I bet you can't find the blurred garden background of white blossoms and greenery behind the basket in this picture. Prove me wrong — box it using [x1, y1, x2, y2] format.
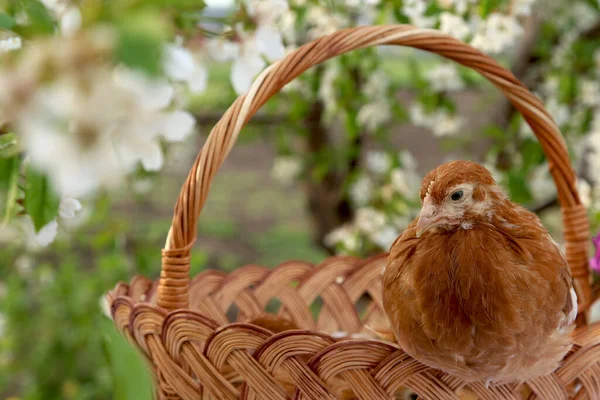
[0, 0, 600, 400]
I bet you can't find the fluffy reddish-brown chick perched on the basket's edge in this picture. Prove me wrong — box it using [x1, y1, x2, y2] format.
[383, 161, 577, 384]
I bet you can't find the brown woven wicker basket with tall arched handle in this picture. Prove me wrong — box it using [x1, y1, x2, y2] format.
[107, 25, 600, 400]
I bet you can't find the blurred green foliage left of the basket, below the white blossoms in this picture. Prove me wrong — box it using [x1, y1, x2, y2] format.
[0, 193, 161, 400]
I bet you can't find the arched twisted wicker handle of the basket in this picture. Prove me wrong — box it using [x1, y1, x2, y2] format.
[157, 25, 592, 313]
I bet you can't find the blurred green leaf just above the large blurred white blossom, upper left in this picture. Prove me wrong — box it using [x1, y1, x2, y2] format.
[115, 11, 170, 75]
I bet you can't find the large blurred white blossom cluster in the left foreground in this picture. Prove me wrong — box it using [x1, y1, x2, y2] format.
[5, 43, 195, 197]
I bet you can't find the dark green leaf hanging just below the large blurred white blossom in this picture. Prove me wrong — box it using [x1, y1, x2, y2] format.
[25, 167, 60, 231]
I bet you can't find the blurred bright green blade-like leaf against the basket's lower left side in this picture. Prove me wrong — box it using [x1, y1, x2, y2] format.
[101, 319, 152, 400]
